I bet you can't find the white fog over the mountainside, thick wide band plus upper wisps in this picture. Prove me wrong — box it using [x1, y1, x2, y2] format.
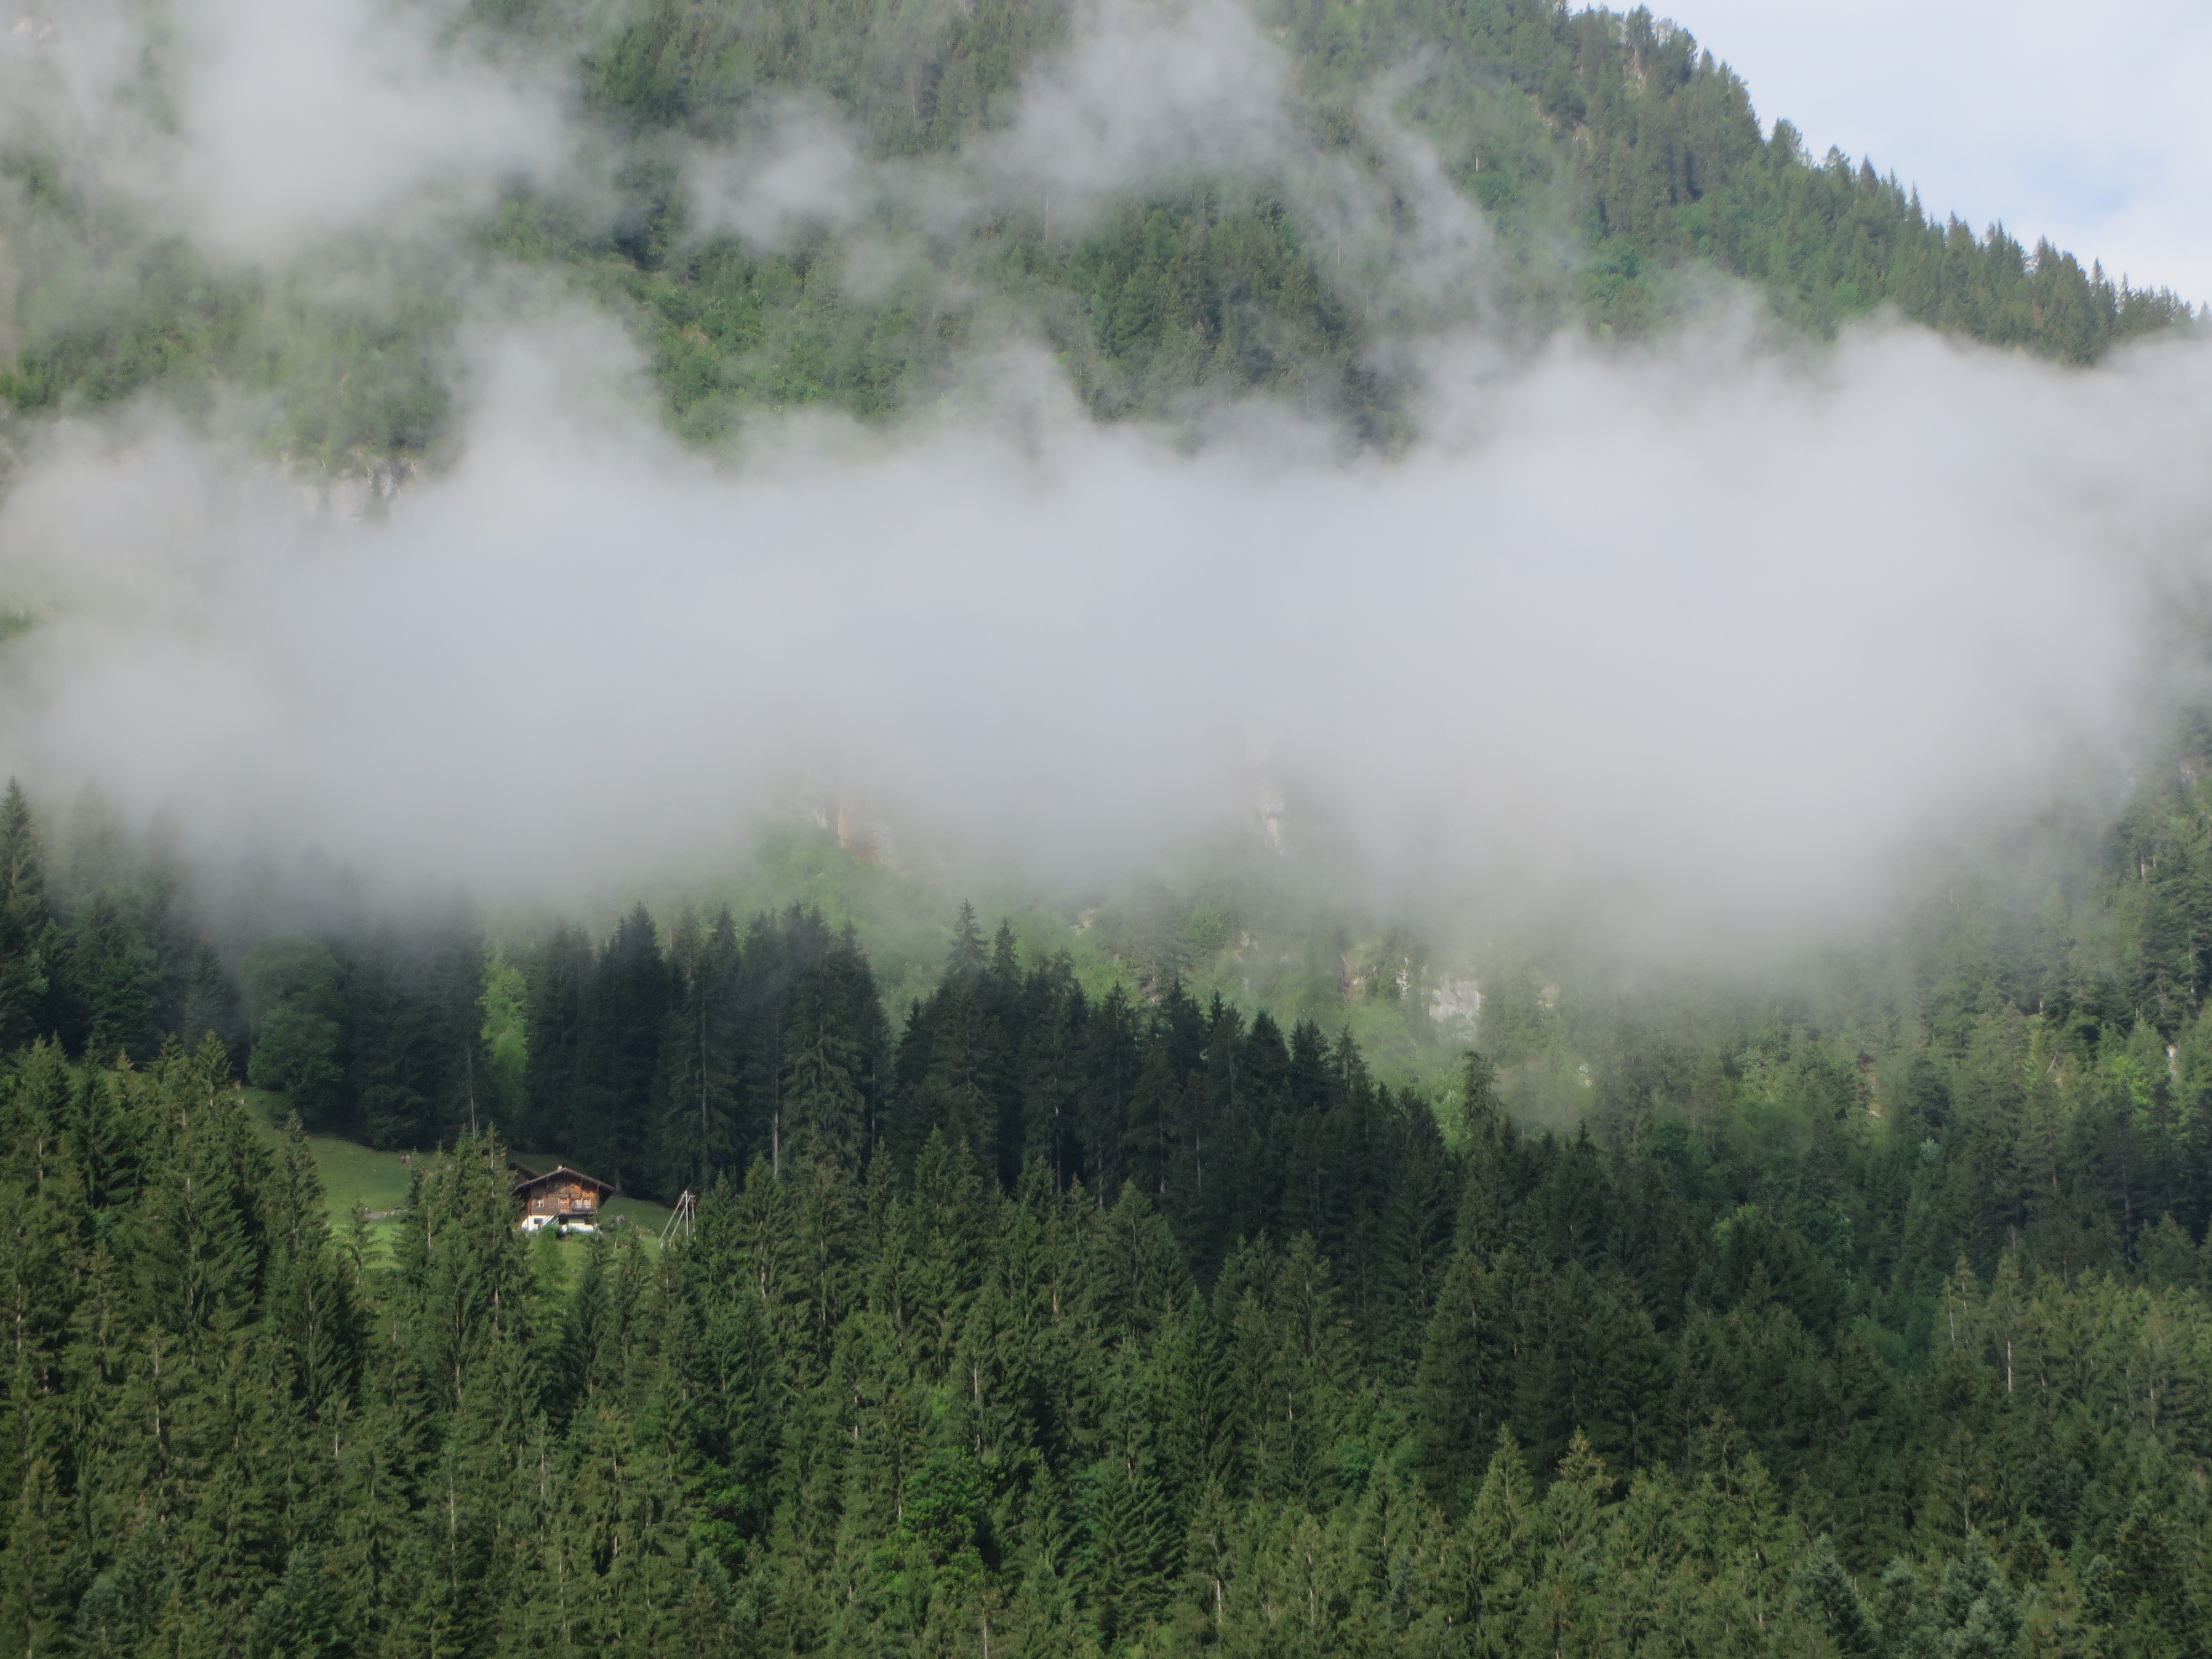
[0, 0, 2212, 945]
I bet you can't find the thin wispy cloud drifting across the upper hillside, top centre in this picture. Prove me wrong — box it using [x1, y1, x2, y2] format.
[664, 0, 1498, 354]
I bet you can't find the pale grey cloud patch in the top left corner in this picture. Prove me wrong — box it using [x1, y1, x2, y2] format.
[0, 0, 568, 263]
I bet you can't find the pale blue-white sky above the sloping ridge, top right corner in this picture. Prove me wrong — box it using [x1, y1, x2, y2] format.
[1661, 0, 2212, 303]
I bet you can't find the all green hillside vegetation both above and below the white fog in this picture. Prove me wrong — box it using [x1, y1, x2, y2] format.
[0, 0, 2212, 1659]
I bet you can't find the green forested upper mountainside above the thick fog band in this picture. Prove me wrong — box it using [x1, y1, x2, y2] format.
[0, 0, 2190, 478]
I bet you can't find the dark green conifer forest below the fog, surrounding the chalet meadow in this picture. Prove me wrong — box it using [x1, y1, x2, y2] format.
[0, 748, 2212, 1659]
